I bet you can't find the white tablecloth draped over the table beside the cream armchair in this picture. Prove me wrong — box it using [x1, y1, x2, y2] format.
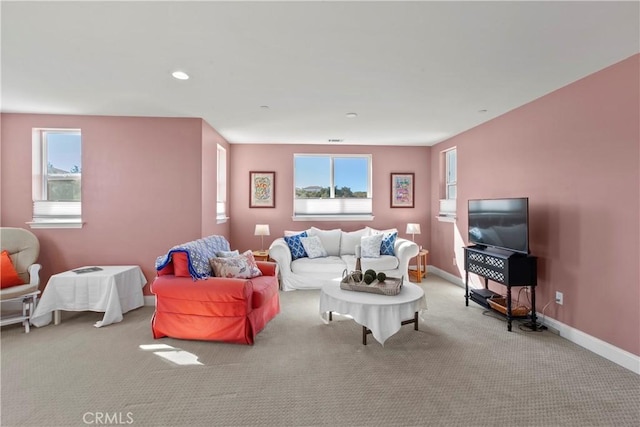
[31, 265, 147, 328]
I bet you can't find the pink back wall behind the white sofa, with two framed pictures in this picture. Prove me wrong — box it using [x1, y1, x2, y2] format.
[230, 144, 431, 250]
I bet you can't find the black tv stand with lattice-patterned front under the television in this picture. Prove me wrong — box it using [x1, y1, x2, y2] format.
[464, 246, 538, 331]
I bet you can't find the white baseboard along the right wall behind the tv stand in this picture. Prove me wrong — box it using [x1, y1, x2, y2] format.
[427, 265, 640, 375]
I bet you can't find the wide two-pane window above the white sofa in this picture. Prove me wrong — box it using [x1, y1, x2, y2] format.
[293, 154, 373, 220]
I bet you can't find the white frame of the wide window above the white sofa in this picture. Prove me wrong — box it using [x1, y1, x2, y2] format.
[292, 153, 374, 221]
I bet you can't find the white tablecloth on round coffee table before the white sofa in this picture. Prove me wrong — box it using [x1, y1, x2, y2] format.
[320, 280, 427, 345]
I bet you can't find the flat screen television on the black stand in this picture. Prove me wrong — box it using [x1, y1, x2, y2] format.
[469, 197, 529, 254]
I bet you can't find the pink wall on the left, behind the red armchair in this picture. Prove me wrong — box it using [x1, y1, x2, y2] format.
[0, 114, 228, 293]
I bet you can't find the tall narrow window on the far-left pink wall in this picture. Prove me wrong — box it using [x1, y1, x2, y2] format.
[29, 129, 82, 228]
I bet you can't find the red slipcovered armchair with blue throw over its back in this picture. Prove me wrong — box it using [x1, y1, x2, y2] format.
[151, 261, 280, 344]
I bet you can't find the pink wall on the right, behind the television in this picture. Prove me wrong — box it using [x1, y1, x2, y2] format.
[430, 55, 640, 355]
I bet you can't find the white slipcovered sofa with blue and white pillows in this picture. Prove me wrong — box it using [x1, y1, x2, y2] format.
[269, 227, 419, 291]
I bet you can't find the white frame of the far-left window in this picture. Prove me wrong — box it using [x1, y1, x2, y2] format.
[27, 128, 84, 228]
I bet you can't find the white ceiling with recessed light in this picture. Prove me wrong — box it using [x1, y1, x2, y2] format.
[0, 1, 640, 145]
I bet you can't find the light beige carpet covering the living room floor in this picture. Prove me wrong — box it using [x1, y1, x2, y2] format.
[0, 275, 640, 426]
